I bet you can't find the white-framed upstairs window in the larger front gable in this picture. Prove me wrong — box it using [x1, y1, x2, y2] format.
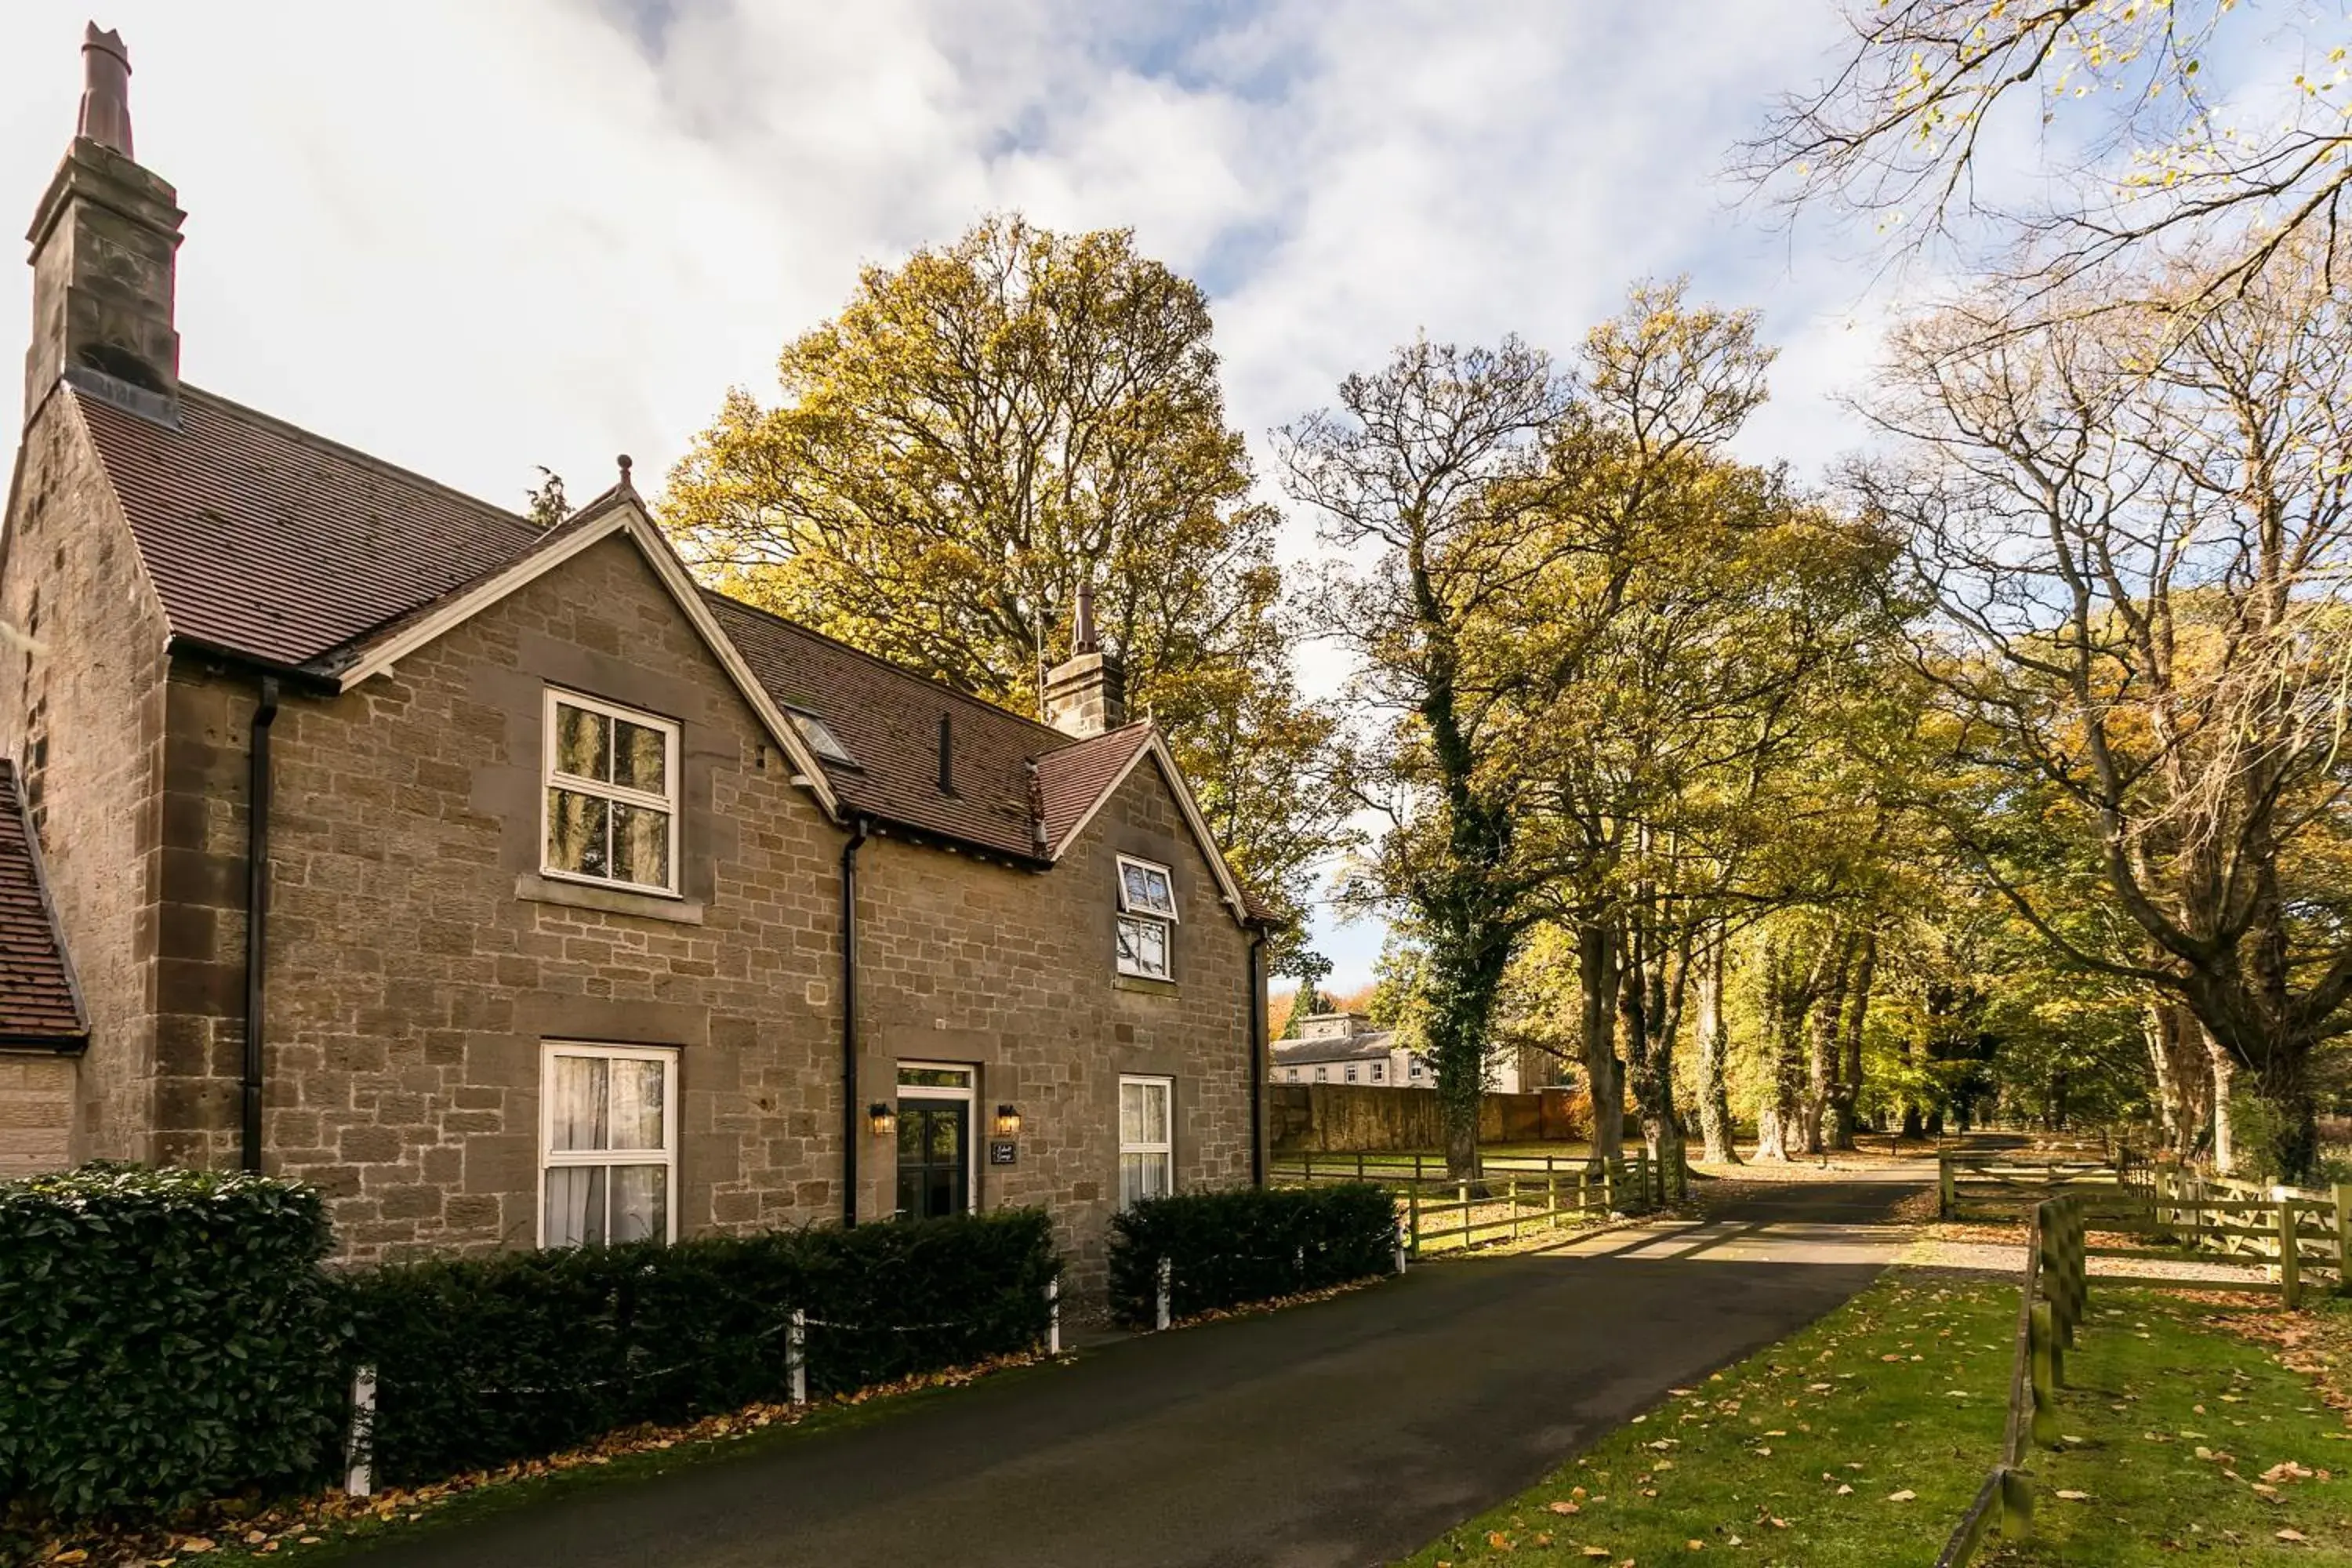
[539, 687, 677, 893]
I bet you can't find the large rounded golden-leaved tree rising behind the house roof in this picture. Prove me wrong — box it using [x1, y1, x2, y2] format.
[663, 216, 1345, 959]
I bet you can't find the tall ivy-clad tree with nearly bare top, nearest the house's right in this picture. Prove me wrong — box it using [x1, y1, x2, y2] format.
[1279, 339, 1566, 1175]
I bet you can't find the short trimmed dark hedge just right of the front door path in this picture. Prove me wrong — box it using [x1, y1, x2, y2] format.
[1110, 1182, 1397, 1326]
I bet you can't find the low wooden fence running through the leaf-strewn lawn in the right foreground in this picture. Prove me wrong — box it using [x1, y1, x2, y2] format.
[1936, 1196, 2091, 1568]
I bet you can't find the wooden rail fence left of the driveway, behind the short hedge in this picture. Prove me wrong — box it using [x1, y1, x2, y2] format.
[1268, 1145, 1665, 1258]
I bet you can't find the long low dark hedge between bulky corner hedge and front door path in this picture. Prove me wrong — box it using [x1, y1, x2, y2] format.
[348, 1210, 1061, 1483]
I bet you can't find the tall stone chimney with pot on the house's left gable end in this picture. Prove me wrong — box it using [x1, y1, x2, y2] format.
[24, 24, 188, 421]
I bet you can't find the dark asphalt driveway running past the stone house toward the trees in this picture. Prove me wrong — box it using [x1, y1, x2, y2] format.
[336, 1180, 1905, 1568]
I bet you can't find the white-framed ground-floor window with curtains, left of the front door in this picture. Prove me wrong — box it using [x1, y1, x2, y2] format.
[539, 1039, 677, 1246]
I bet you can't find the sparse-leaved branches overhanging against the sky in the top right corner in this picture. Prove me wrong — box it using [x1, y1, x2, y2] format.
[1740, 0, 2352, 303]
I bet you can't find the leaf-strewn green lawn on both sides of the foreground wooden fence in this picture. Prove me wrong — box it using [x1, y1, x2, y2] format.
[1409, 1269, 2352, 1568]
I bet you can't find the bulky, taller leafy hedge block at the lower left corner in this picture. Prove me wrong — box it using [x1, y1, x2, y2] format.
[0, 1166, 341, 1516]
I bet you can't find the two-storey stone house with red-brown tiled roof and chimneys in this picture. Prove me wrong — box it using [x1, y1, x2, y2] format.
[0, 31, 1265, 1288]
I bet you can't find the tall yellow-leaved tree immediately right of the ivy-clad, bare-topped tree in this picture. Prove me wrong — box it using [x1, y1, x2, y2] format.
[1491, 282, 1891, 1180]
